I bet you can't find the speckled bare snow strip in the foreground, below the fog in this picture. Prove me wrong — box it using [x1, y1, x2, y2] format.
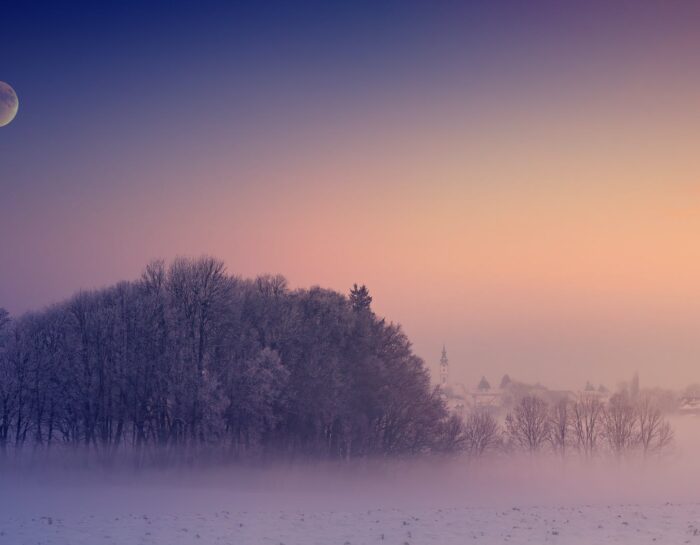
[0, 504, 700, 545]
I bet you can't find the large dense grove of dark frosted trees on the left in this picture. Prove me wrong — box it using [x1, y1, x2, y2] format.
[0, 257, 461, 458]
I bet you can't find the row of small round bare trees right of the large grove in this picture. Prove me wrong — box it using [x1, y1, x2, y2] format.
[453, 392, 674, 459]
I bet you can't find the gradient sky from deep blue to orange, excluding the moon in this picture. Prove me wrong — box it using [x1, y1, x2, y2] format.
[0, 1, 700, 388]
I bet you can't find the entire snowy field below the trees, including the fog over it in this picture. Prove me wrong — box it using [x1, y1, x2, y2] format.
[0, 416, 700, 545]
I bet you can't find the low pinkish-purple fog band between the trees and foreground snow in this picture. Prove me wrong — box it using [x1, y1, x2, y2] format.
[0, 417, 700, 516]
